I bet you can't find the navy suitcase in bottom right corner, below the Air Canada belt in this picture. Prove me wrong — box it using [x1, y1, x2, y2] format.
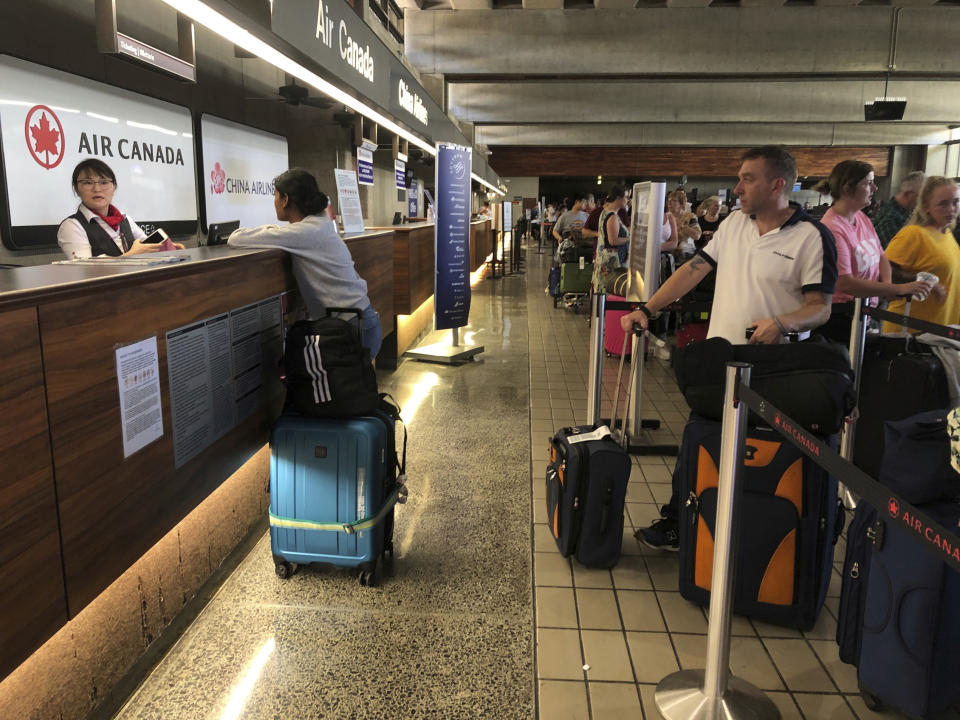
[857, 502, 960, 718]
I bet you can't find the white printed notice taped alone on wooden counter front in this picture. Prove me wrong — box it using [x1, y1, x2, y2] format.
[114, 337, 163, 458]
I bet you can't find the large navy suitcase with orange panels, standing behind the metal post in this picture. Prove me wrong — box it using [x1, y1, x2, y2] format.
[674, 415, 840, 629]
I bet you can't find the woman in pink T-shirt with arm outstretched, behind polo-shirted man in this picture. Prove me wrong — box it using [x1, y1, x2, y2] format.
[814, 160, 930, 345]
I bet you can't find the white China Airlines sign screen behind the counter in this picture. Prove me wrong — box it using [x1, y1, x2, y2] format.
[200, 115, 290, 232]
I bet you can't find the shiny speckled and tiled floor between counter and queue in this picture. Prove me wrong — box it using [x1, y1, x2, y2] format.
[117, 249, 891, 720]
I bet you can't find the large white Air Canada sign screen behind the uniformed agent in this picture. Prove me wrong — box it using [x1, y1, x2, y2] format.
[0, 55, 197, 250]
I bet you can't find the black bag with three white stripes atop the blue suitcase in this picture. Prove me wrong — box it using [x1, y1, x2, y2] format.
[283, 308, 380, 418]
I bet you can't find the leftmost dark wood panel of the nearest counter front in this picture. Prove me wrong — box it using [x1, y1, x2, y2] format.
[0, 308, 67, 677]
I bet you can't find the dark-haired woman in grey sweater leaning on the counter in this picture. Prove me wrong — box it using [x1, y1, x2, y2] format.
[227, 168, 383, 360]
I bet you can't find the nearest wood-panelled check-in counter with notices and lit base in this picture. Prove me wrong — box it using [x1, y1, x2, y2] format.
[0, 231, 394, 677]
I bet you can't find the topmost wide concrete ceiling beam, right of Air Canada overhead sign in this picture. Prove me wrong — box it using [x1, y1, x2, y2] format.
[404, 7, 960, 76]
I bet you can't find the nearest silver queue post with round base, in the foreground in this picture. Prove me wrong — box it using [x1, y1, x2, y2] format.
[654, 363, 780, 720]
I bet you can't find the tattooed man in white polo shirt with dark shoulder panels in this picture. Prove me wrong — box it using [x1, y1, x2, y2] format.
[621, 145, 837, 550]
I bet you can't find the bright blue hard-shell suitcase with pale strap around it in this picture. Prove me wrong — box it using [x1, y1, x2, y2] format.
[270, 411, 406, 585]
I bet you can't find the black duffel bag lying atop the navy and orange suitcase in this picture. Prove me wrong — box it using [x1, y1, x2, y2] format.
[674, 336, 856, 435]
